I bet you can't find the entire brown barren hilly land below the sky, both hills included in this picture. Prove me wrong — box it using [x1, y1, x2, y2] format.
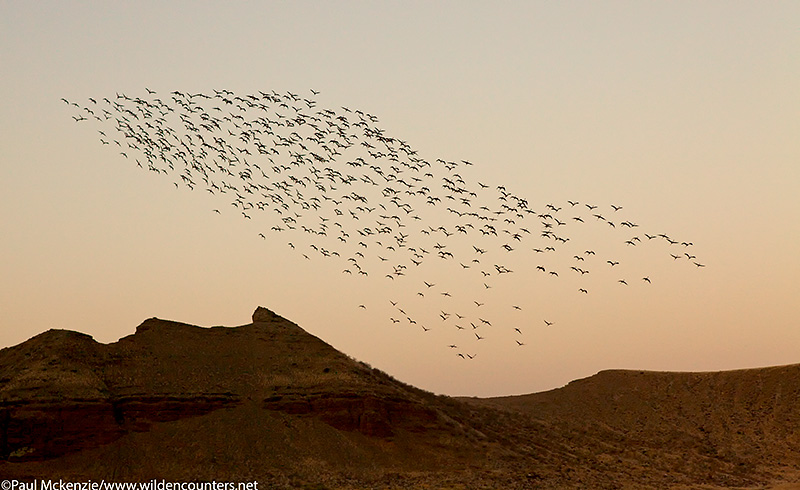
[0, 307, 800, 489]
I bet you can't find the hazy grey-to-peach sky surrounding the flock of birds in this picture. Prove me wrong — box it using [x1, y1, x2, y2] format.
[0, 0, 800, 396]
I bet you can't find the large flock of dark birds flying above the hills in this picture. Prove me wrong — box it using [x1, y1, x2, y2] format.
[62, 89, 704, 359]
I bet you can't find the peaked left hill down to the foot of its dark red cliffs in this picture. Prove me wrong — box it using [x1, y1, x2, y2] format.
[0, 307, 445, 461]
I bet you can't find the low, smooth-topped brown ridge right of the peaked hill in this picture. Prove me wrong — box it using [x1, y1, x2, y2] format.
[472, 364, 800, 484]
